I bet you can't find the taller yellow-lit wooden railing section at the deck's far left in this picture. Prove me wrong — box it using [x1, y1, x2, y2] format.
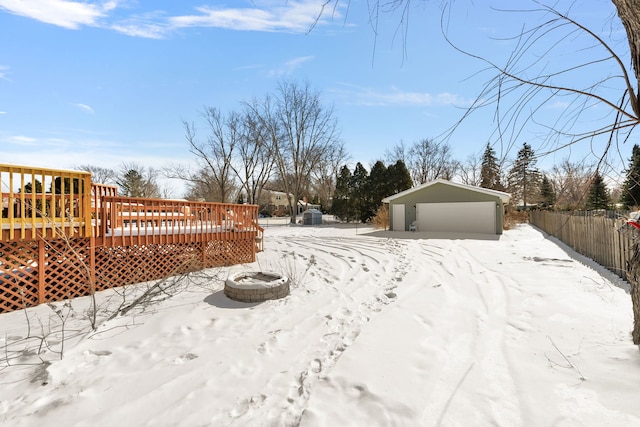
[0, 164, 92, 240]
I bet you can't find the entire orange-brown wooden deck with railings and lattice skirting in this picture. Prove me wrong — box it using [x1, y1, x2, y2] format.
[0, 164, 264, 313]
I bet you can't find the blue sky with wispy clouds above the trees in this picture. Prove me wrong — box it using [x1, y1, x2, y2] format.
[0, 0, 631, 194]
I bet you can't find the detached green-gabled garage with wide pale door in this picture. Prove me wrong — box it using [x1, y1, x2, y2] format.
[382, 179, 511, 234]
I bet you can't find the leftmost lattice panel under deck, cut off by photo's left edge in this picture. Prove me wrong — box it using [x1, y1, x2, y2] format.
[0, 241, 38, 313]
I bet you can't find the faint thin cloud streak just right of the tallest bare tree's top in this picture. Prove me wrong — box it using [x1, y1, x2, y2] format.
[333, 86, 472, 107]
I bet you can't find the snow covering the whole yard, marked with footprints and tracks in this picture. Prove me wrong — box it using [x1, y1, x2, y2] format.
[0, 225, 640, 426]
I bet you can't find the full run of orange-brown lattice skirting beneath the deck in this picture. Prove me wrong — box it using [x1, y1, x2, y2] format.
[0, 234, 256, 313]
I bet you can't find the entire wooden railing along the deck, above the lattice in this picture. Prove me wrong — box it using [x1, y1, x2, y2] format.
[0, 164, 264, 251]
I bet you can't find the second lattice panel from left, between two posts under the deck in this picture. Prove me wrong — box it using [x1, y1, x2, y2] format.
[42, 239, 91, 302]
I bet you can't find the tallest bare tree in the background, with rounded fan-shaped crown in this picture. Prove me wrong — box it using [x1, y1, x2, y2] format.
[259, 81, 341, 223]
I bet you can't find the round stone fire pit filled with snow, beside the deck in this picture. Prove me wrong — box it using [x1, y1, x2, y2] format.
[224, 271, 289, 302]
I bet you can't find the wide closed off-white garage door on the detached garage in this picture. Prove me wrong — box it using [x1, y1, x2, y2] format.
[416, 202, 496, 234]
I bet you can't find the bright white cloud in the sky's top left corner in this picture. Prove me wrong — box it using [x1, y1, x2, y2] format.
[0, 0, 106, 29]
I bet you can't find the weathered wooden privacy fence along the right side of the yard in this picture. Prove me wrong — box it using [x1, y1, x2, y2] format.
[529, 211, 635, 280]
